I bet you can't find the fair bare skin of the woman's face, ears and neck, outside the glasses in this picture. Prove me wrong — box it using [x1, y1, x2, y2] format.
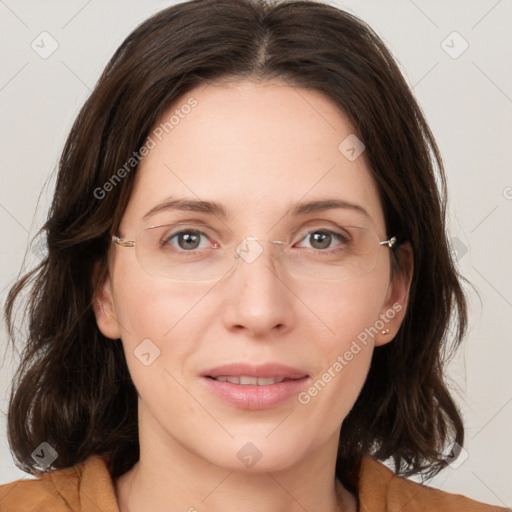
[95, 81, 412, 512]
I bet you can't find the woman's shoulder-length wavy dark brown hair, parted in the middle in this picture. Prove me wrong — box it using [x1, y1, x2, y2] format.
[5, 0, 467, 487]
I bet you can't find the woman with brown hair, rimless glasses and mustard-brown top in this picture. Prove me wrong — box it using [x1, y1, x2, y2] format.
[0, 0, 504, 512]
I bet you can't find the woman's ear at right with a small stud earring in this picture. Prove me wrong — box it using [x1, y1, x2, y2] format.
[374, 242, 414, 347]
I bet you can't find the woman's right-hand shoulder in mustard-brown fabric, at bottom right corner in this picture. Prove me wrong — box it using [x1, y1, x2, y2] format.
[358, 457, 510, 512]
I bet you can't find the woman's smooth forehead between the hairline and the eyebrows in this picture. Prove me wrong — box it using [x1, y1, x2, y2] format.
[123, 81, 383, 230]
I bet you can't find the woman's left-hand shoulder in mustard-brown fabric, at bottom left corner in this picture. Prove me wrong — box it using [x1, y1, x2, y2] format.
[0, 455, 118, 512]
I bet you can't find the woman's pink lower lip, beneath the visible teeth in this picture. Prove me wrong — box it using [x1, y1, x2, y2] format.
[204, 377, 308, 411]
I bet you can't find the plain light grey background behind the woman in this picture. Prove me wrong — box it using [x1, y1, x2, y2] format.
[0, 0, 512, 507]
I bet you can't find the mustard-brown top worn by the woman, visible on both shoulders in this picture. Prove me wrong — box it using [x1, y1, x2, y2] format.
[0, 456, 511, 512]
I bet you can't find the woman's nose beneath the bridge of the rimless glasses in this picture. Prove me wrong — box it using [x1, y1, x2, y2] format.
[222, 237, 296, 339]
